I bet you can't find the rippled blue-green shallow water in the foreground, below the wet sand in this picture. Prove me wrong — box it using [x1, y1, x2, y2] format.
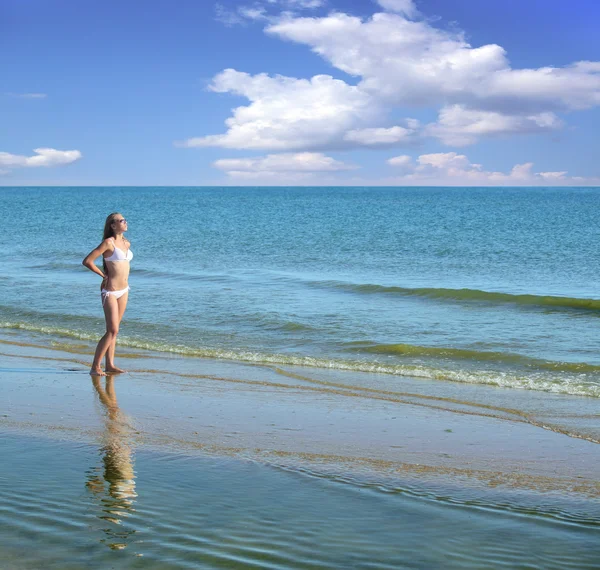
[0, 433, 600, 570]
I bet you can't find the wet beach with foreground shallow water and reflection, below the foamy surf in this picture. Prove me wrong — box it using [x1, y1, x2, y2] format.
[0, 335, 600, 568]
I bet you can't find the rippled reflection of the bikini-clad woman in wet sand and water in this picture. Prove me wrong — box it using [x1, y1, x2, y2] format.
[86, 376, 137, 549]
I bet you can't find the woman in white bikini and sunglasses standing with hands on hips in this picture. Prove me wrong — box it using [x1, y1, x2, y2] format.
[82, 212, 133, 376]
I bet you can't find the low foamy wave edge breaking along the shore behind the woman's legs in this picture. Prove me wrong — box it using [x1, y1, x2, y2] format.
[0, 315, 600, 398]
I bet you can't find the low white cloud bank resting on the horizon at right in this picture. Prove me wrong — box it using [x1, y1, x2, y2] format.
[387, 152, 600, 186]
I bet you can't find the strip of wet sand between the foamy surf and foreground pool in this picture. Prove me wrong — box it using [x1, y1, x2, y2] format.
[0, 332, 600, 499]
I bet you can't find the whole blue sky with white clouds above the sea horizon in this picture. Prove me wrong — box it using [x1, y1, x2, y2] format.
[0, 0, 600, 186]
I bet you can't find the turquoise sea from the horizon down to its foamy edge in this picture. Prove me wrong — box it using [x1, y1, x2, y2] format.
[0, 188, 600, 398]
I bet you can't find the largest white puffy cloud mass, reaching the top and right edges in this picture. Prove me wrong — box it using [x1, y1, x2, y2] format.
[192, 0, 600, 151]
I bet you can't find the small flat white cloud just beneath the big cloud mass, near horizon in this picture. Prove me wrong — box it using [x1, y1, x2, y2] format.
[213, 152, 357, 175]
